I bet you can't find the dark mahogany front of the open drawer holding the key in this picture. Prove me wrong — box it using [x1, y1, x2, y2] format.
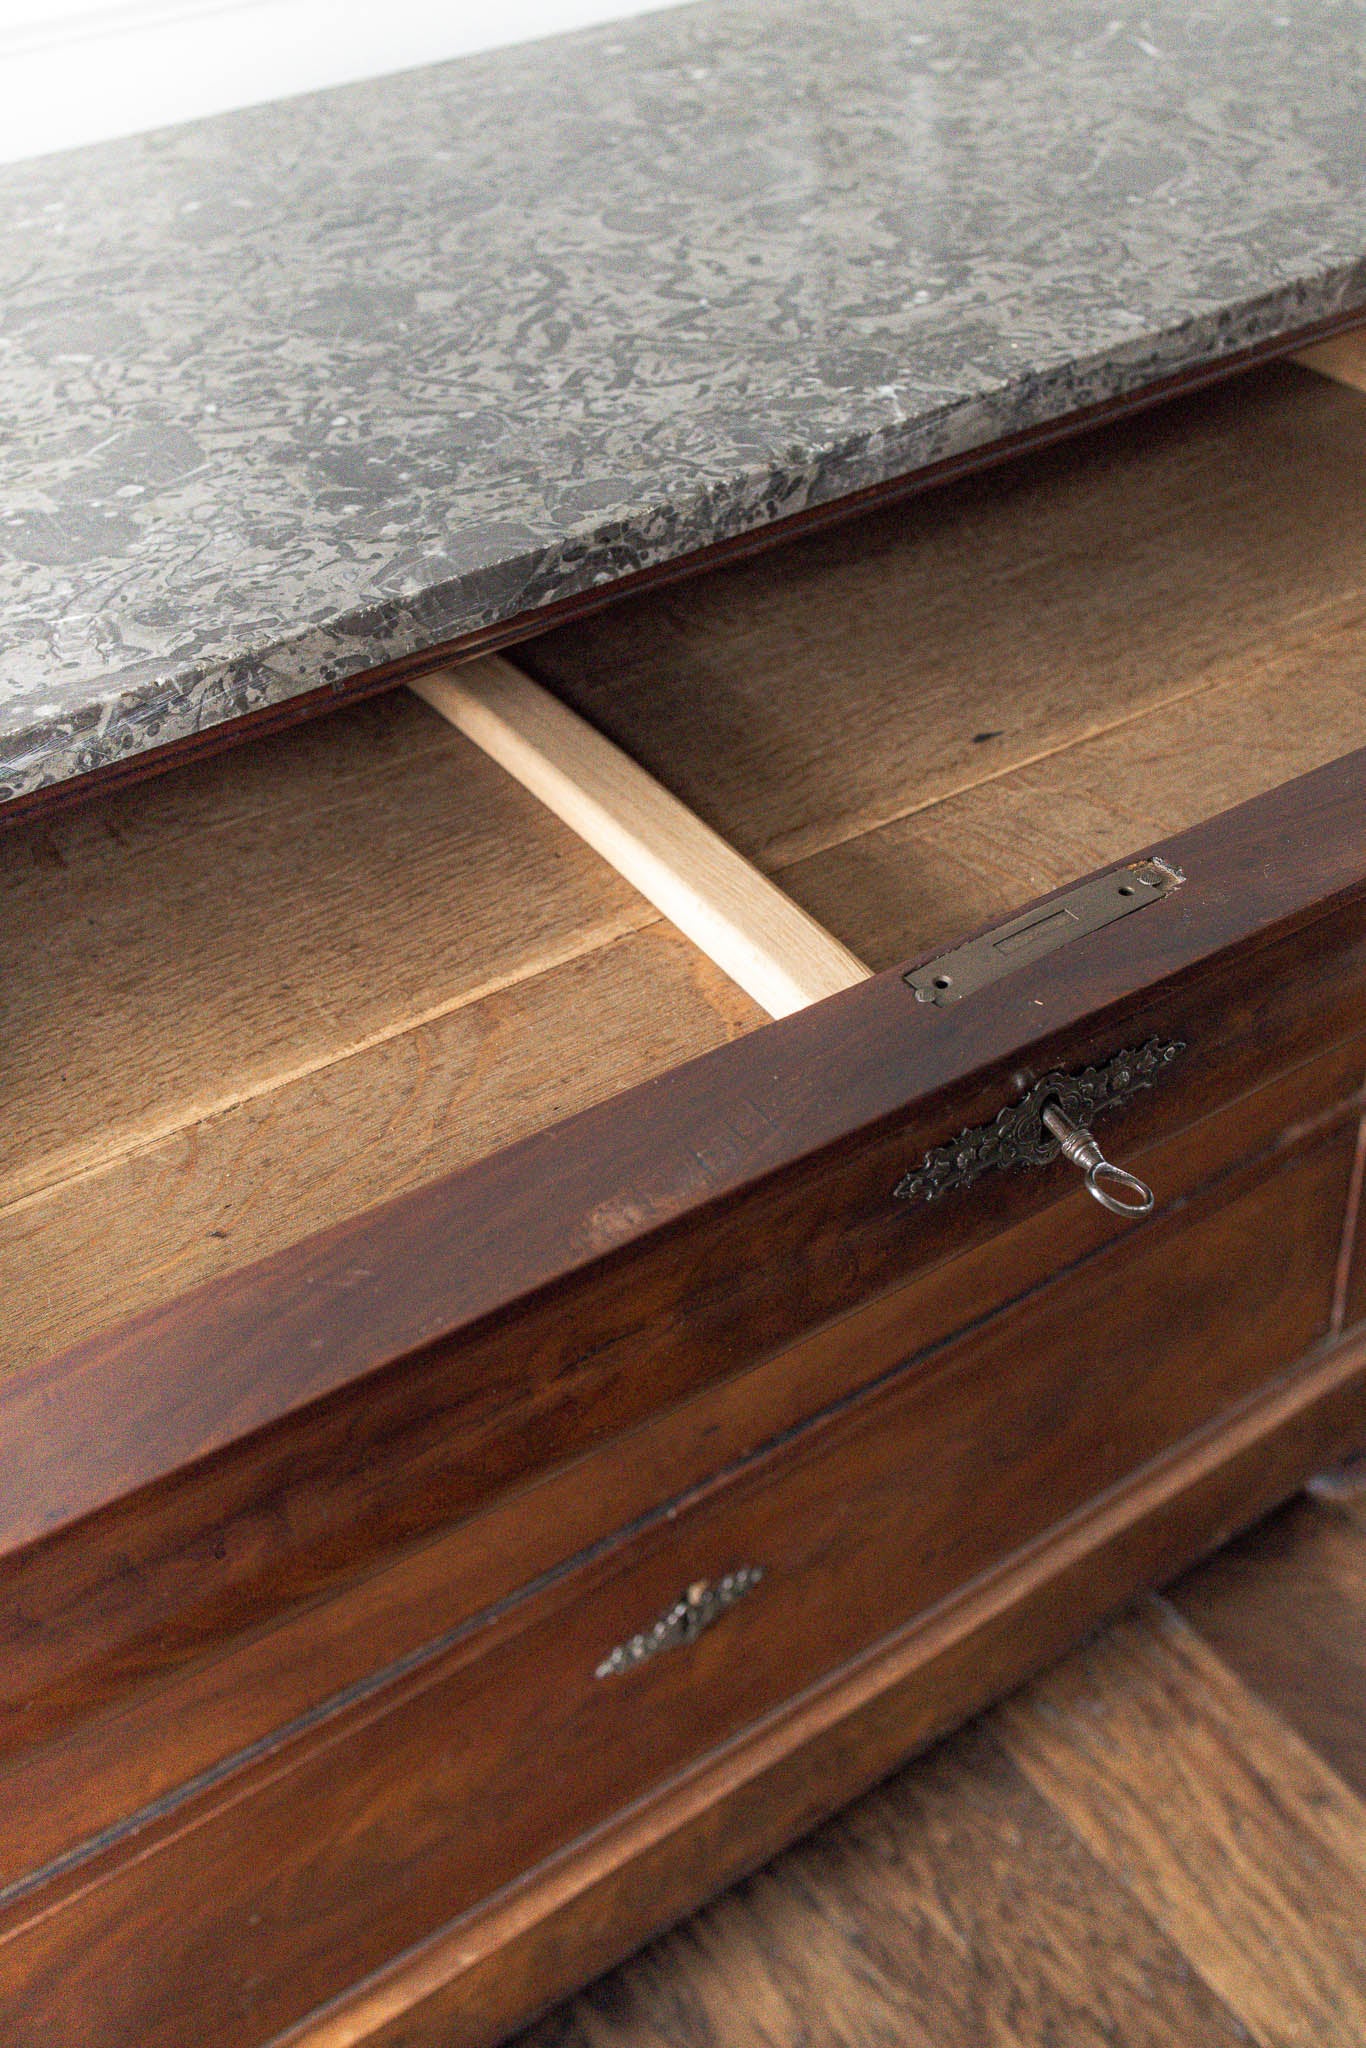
[0, 864, 1366, 1751]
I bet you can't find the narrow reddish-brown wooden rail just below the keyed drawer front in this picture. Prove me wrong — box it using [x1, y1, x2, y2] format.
[0, 1036, 1366, 1886]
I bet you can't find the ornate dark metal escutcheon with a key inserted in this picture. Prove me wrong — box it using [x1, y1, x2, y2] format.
[893, 1038, 1186, 1217]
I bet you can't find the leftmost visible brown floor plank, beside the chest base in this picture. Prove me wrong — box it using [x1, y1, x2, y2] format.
[520, 1726, 1245, 2048]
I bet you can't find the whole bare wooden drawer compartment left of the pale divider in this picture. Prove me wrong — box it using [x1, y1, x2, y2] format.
[0, 698, 762, 1372]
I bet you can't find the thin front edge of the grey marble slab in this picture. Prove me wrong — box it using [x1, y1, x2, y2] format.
[0, 256, 1366, 811]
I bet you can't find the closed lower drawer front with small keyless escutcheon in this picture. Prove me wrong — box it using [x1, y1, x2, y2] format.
[0, 1122, 1354, 2048]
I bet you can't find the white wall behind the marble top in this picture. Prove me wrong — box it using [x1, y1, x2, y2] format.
[0, 0, 676, 162]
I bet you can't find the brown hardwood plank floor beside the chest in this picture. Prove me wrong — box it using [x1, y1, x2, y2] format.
[516, 1489, 1366, 2048]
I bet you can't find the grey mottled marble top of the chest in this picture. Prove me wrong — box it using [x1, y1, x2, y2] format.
[0, 0, 1366, 797]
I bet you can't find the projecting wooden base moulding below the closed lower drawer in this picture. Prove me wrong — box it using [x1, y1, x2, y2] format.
[281, 1348, 1366, 2048]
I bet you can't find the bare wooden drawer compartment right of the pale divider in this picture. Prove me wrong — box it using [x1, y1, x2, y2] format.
[518, 365, 1366, 969]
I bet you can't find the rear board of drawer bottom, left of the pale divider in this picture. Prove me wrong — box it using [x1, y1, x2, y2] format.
[0, 700, 651, 1202]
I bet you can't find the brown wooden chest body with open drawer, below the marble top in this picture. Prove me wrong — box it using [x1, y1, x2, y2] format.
[0, 352, 1366, 2048]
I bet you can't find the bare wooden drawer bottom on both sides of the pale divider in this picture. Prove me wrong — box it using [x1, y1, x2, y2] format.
[0, 367, 1366, 1364]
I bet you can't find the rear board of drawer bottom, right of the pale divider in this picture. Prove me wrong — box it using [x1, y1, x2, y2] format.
[518, 369, 1366, 872]
